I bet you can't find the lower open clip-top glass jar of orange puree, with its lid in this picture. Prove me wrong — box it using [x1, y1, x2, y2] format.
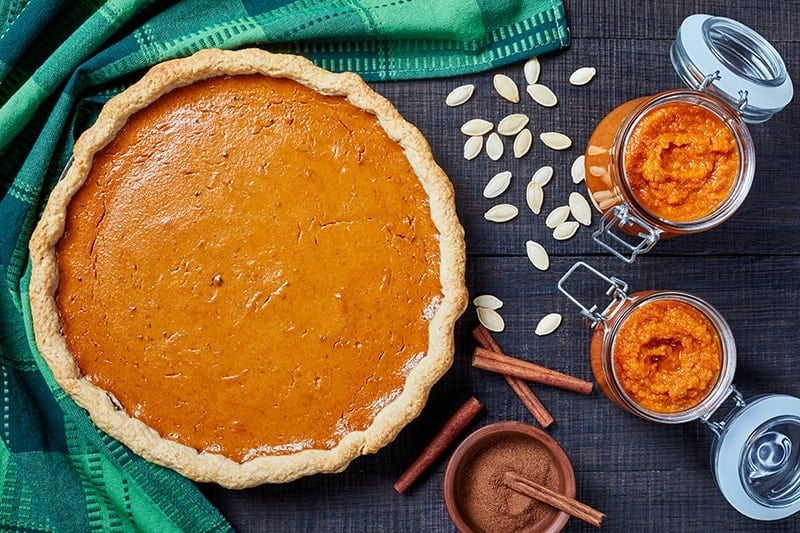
[558, 262, 800, 520]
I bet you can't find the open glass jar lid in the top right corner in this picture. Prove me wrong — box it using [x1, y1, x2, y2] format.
[670, 14, 794, 123]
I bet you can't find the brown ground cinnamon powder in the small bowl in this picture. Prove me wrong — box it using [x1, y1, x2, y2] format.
[456, 434, 563, 533]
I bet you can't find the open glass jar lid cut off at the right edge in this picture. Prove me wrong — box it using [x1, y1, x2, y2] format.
[711, 394, 800, 520]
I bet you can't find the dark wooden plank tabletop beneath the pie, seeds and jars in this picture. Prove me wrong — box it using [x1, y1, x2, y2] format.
[202, 0, 800, 531]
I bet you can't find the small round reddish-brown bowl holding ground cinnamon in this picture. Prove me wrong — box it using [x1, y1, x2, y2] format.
[444, 421, 575, 533]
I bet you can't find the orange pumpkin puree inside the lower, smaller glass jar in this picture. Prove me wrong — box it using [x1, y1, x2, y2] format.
[612, 299, 722, 413]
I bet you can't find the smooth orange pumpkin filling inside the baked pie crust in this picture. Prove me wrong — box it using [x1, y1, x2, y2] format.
[56, 75, 442, 462]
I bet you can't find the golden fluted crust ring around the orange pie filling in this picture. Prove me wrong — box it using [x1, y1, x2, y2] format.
[30, 49, 467, 488]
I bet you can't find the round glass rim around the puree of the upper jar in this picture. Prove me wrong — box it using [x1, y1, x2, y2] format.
[612, 89, 755, 234]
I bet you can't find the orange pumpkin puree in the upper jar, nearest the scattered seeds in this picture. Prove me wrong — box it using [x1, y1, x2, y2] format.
[624, 102, 740, 222]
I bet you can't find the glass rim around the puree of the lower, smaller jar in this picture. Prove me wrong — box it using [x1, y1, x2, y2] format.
[606, 290, 736, 424]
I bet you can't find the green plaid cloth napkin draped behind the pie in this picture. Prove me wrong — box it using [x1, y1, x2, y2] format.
[0, 0, 569, 531]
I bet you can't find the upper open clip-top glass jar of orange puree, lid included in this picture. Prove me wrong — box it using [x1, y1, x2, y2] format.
[585, 15, 793, 263]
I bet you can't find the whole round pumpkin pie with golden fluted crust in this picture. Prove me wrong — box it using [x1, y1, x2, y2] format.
[30, 49, 466, 488]
